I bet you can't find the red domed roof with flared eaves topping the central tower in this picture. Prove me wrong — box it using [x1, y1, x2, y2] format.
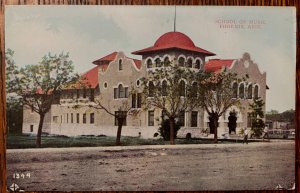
[132, 32, 215, 56]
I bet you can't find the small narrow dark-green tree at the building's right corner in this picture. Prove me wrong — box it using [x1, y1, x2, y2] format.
[250, 98, 265, 137]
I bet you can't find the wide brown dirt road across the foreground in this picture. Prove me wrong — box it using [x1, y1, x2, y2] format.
[7, 141, 295, 191]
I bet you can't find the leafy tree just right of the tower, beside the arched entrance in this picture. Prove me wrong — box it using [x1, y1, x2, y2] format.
[197, 71, 241, 143]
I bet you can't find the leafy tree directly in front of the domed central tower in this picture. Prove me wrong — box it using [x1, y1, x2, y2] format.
[142, 62, 198, 144]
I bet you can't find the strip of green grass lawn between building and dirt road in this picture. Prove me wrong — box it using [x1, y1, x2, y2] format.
[7, 135, 232, 149]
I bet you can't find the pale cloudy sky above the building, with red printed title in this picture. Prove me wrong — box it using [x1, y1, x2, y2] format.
[5, 5, 296, 112]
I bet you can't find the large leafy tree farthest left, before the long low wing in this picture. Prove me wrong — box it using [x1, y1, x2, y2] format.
[9, 53, 78, 147]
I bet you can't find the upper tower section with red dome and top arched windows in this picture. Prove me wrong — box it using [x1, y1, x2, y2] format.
[132, 32, 215, 70]
